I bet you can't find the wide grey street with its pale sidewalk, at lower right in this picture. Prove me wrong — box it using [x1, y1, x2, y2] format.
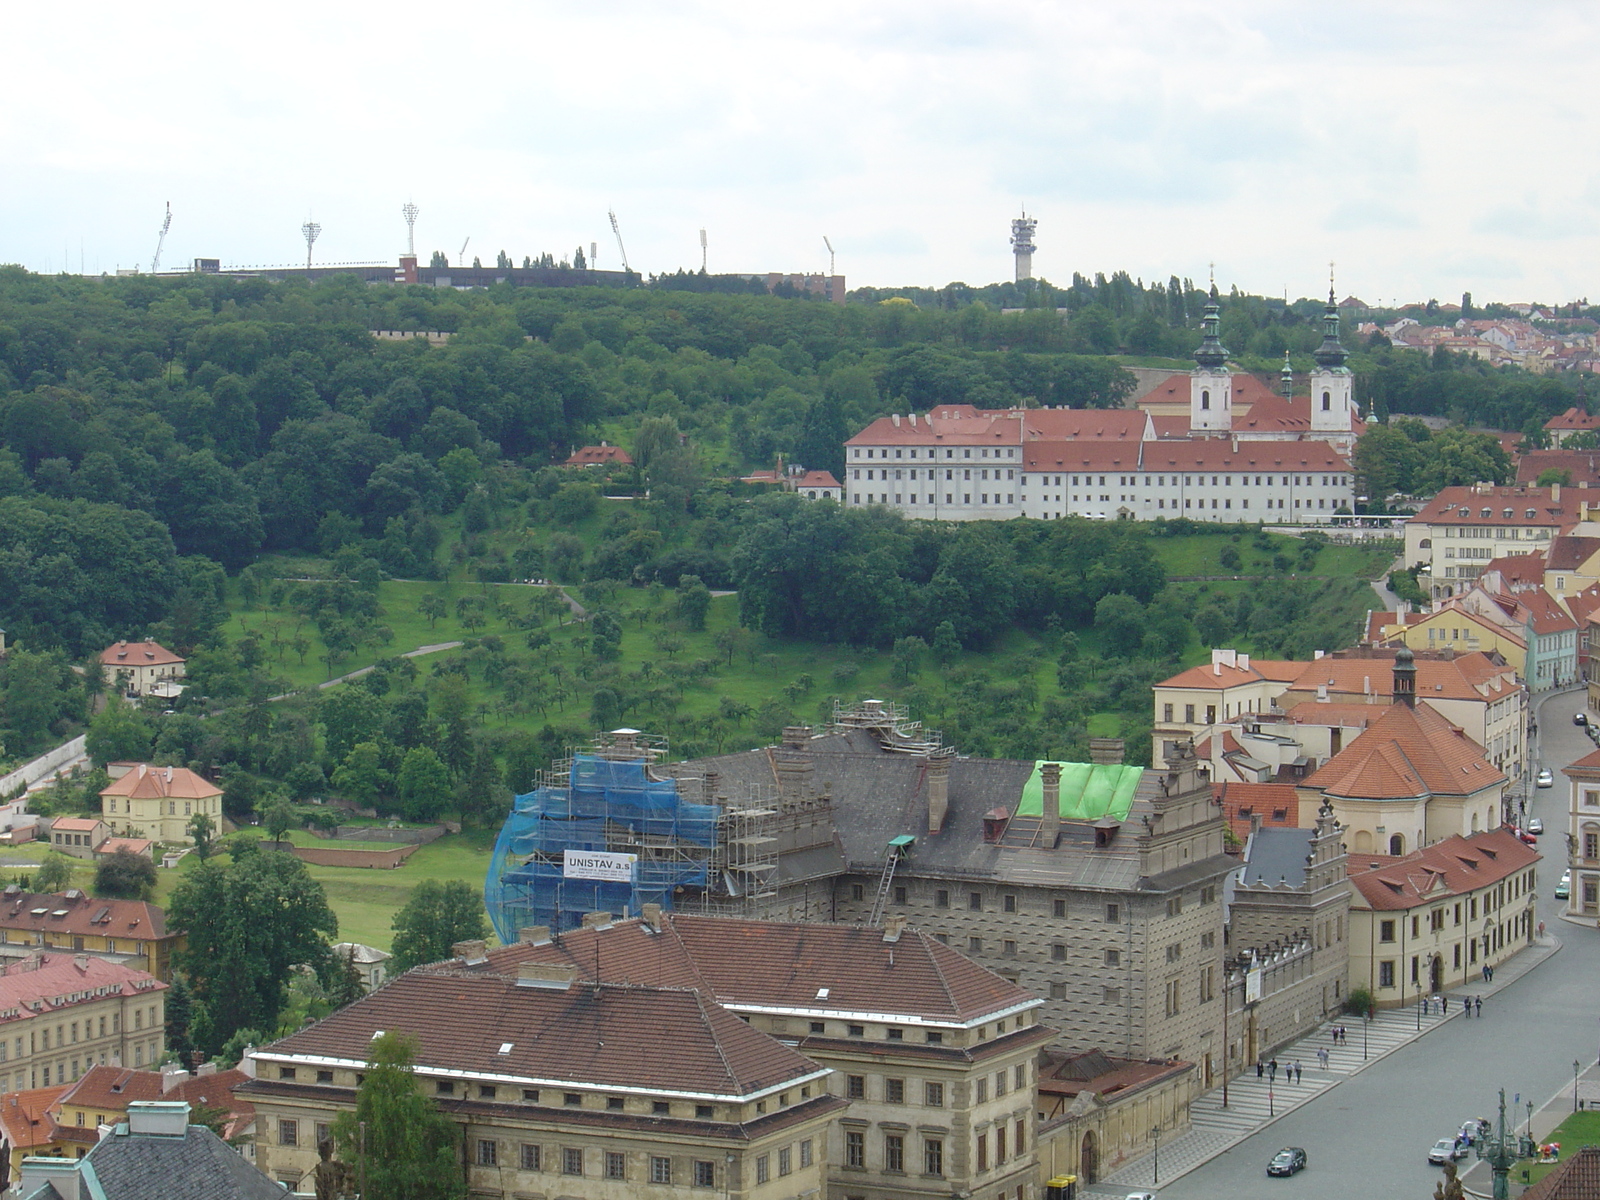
[1094, 693, 1600, 1200]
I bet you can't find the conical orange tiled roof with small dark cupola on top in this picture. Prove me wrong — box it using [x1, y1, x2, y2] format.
[1304, 704, 1506, 800]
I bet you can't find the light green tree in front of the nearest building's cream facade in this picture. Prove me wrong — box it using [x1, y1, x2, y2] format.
[333, 1032, 467, 1200]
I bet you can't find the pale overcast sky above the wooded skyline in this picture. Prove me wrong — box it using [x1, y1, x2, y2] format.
[0, 0, 1600, 310]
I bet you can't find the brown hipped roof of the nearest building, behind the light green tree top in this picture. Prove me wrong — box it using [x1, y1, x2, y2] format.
[261, 972, 819, 1099]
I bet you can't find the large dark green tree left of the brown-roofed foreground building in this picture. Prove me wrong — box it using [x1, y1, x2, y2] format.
[166, 846, 339, 1054]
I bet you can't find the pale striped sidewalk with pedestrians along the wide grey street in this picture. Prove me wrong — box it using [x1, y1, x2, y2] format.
[1082, 931, 1562, 1200]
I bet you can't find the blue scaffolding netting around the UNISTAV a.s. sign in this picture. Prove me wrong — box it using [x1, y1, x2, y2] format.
[483, 755, 720, 944]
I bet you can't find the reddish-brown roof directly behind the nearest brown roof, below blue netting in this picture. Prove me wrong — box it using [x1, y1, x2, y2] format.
[435, 914, 1037, 1024]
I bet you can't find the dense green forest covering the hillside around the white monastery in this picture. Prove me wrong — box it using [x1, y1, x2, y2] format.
[0, 269, 1573, 790]
